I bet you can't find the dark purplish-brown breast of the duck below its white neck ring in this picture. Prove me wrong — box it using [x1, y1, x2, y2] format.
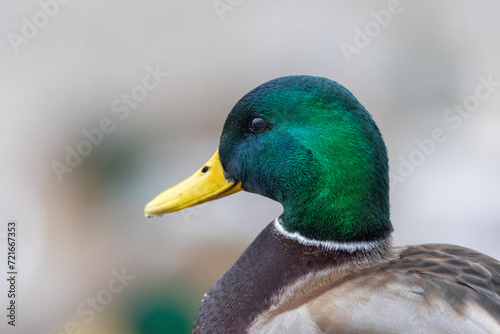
[193, 223, 392, 333]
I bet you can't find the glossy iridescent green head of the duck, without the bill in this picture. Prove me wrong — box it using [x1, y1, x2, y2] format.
[219, 76, 392, 242]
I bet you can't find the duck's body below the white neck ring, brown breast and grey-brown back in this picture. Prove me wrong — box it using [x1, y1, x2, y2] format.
[193, 224, 500, 333]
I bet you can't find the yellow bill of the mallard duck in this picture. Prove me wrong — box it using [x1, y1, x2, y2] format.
[144, 150, 242, 217]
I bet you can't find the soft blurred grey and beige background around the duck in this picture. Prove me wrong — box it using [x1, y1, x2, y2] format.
[0, 0, 500, 334]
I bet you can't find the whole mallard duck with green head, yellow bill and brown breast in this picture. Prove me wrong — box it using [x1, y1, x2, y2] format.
[145, 76, 500, 333]
